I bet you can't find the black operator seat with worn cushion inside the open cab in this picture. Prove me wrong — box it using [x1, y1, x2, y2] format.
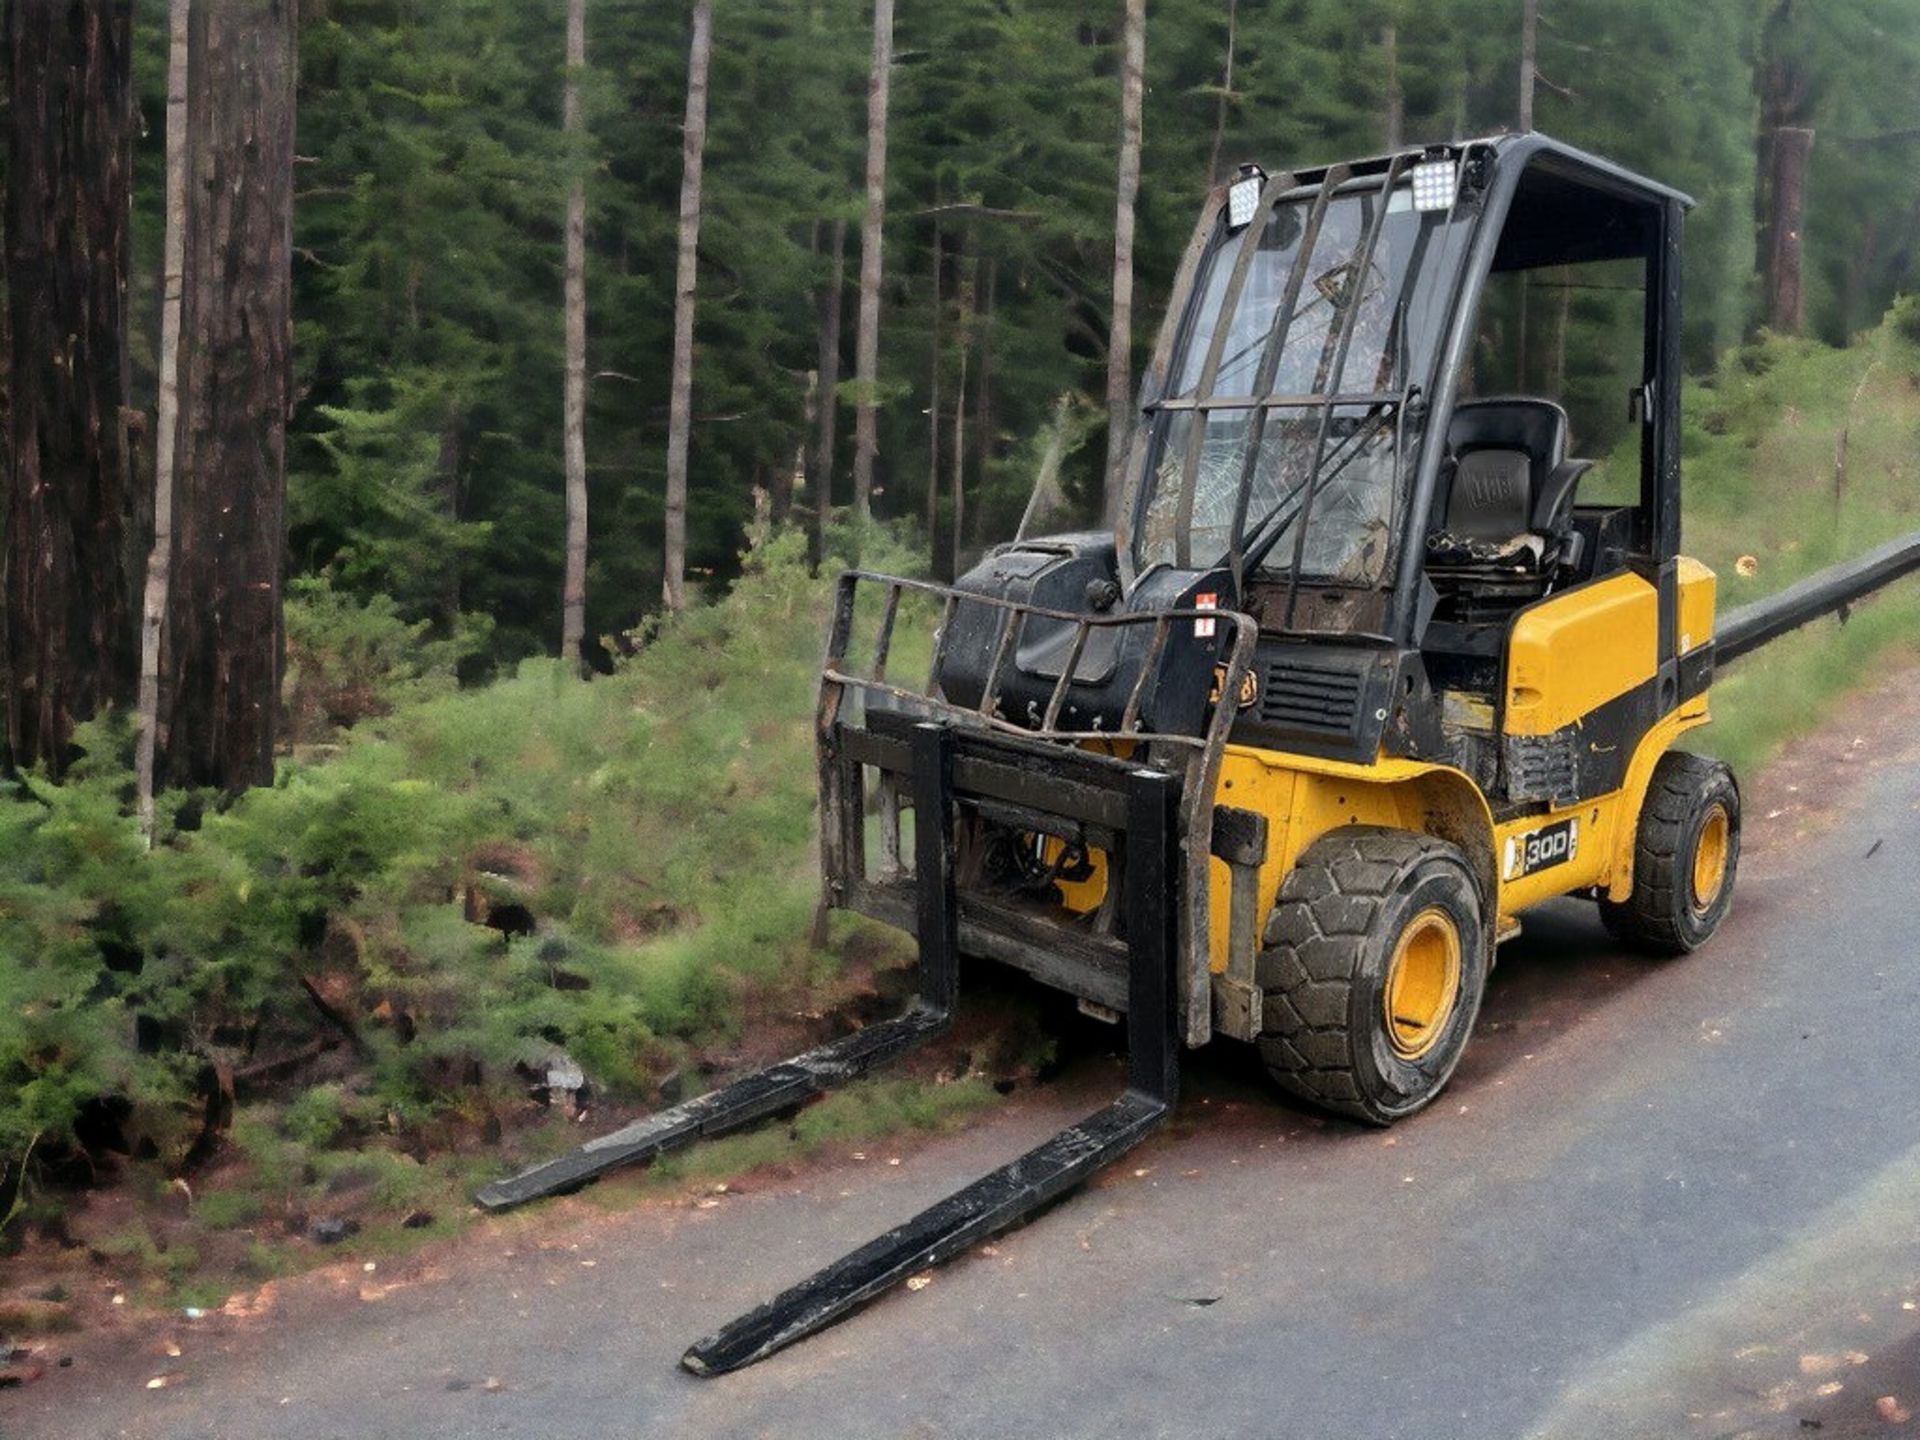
[1427, 396, 1594, 576]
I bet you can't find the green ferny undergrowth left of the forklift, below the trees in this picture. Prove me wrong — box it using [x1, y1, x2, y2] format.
[0, 534, 929, 1281]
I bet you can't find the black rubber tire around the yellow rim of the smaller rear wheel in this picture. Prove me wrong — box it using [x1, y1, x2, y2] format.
[1599, 751, 1740, 956]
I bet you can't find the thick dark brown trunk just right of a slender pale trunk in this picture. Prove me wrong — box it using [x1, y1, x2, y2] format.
[156, 0, 298, 791]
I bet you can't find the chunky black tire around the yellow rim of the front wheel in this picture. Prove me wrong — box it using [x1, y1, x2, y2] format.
[1258, 826, 1488, 1125]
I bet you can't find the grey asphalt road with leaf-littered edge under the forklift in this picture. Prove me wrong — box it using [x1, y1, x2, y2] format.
[0, 682, 1920, 1440]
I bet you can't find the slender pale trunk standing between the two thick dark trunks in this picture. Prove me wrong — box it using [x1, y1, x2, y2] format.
[134, 0, 192, 843]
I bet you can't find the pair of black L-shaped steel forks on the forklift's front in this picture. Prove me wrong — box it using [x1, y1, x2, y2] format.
[478, 722, 1179, 1375]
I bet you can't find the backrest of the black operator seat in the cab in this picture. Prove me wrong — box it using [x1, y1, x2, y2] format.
[1442, 396, 1586, 540]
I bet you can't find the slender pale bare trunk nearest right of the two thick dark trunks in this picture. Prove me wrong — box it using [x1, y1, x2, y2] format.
[561, 0, 588, 676]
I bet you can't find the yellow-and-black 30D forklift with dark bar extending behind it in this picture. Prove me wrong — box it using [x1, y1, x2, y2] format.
[480, 134, 1920, 1375]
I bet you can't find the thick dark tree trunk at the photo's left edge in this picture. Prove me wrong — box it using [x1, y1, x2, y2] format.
[6, 0, 144, 772]
